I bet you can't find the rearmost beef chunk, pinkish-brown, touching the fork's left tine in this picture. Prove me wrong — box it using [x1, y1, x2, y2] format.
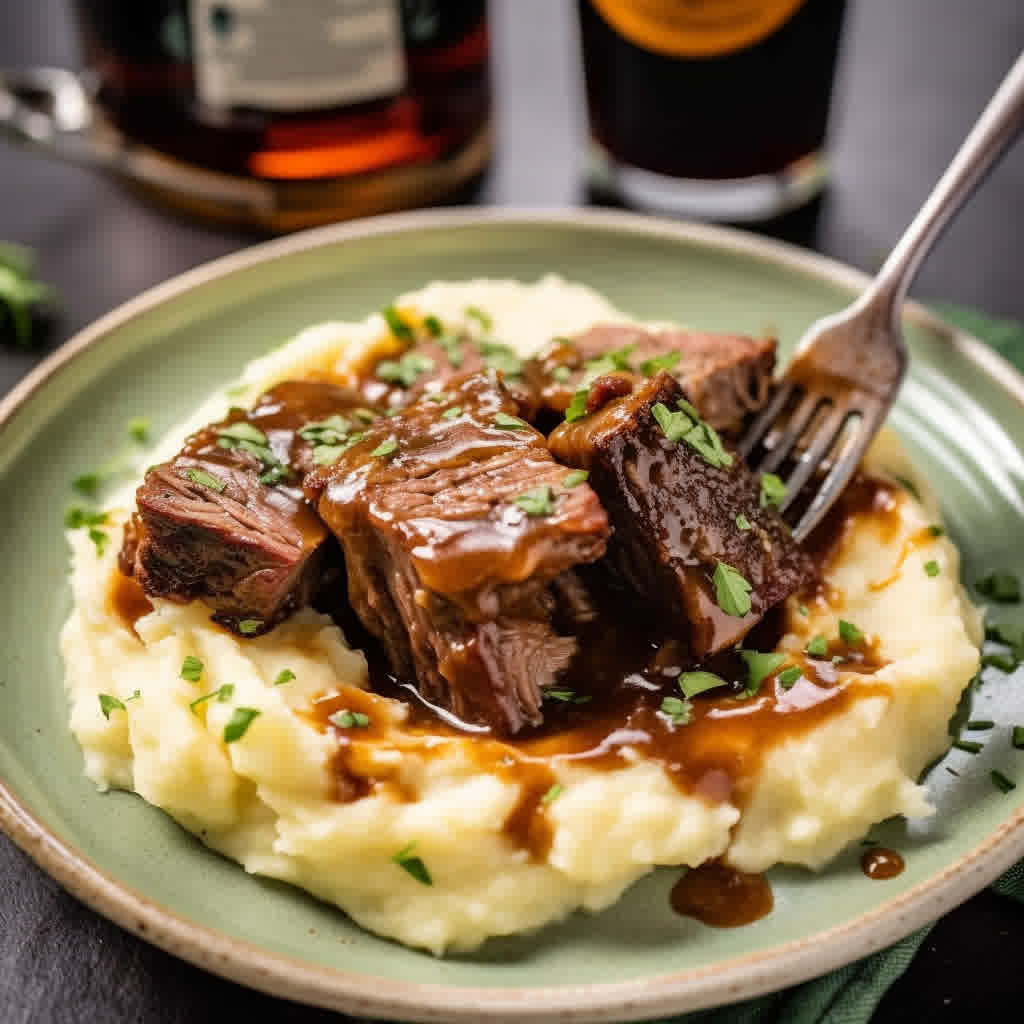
[526, 324, 775, 433]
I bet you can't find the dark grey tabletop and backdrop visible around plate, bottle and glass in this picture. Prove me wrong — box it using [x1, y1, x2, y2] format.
[0, 0, 1024, 1024]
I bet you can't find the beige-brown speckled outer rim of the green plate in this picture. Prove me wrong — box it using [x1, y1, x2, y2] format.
[0, 207, 1024, 1024]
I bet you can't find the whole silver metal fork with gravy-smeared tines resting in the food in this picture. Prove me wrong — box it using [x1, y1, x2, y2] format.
[739, 54, 1024, 541]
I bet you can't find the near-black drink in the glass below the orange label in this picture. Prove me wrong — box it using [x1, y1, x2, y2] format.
[580, 0, 845, 219]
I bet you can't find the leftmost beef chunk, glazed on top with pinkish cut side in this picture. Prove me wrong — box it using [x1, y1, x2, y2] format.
[120, 381, 378, 636]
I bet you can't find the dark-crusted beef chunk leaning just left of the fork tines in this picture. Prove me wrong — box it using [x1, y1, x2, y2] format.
[549, 371, 813, 658]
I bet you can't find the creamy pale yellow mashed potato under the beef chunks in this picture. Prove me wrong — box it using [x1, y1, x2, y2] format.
[61, 276, 980, 953]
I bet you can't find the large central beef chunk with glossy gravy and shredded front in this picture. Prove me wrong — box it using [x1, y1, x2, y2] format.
[306, 374, 608, 733]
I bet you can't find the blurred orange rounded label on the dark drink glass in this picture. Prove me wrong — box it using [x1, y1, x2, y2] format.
[591, 0, 807, 57]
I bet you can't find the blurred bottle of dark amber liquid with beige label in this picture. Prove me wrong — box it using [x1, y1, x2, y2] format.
[77, 0, 490, 228]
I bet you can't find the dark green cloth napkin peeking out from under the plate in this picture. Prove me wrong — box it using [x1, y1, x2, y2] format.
[662, 305, 1024, 1024]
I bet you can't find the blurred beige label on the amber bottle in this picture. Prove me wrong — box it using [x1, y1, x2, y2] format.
[188, 0, 406, 112]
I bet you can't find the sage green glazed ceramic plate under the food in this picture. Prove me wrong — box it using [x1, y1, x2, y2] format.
[0, 210, 1024, 1022]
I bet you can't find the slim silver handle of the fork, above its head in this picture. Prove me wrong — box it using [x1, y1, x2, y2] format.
[857, 53, 1024, 330]
